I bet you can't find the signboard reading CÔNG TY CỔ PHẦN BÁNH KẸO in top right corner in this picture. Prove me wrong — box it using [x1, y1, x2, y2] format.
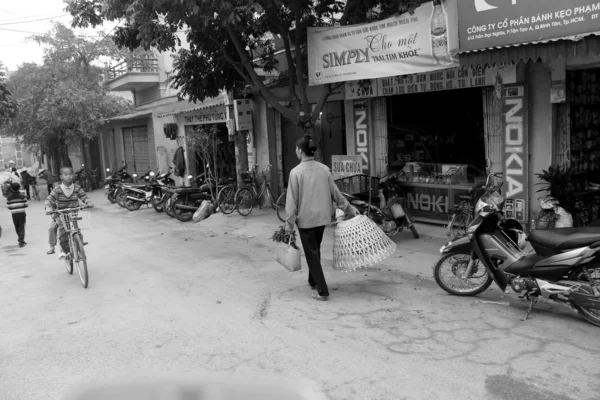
[458, 0, 600, 52]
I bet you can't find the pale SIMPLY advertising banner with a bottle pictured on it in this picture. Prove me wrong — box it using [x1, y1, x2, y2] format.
[308, 0, 459, 86]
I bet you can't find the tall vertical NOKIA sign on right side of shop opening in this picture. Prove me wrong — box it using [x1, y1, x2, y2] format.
[502, 86, 529, 223]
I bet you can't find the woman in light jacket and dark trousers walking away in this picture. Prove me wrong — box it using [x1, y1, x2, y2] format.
[285, 135, 358, 301]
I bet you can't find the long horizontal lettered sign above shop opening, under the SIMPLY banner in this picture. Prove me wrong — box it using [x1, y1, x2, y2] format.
[377, 65, 517, 96]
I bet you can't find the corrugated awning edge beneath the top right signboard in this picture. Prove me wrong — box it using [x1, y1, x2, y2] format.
[460, 32, 600, 67]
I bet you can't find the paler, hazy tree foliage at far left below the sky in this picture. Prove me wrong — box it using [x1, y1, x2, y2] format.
[8, 24, 132, 156]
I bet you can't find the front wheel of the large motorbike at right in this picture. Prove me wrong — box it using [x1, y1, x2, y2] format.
[433, 251, 493, 296]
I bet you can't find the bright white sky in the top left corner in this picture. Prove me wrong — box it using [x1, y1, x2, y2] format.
[0, 0, 116, 71]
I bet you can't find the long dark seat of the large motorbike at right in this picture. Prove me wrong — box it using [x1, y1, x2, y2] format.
[527, 227, 600, 251]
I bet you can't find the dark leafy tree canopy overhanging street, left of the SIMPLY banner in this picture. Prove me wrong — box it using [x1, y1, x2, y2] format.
[66, 0, 424, 130]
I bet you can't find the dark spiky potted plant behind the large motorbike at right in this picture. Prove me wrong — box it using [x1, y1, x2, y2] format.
[535, 165, 576, 228]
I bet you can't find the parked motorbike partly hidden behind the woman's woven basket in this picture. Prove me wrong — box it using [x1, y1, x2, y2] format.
[342, 173, 419, 239]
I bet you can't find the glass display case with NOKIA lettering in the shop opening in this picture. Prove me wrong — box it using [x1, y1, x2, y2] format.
[399, 162, 486, 224]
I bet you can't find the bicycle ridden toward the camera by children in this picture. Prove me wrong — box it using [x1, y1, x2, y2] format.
[46, 207, 89, 288]
